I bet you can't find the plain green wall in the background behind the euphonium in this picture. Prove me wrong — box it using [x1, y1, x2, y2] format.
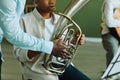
[27, 0, 103, 37]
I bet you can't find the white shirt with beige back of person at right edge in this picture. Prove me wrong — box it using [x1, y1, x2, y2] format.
[101, 0, 120, 34]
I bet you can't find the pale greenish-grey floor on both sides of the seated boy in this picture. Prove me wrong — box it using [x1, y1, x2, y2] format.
[2, 40, 105, 80]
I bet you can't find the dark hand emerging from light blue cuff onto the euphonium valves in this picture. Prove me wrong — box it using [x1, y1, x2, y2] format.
[52, 39, 69, 59]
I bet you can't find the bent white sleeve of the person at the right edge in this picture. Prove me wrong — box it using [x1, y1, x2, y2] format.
[104, 0, 120, 27]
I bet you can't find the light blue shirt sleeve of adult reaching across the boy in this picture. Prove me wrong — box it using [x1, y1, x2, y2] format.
[0, 0, 53, 54]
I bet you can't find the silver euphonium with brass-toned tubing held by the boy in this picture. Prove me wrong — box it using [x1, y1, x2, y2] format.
[44, 0, 89, 74]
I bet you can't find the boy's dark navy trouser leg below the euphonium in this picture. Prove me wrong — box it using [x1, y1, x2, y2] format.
[59, 65, 90, 80]
